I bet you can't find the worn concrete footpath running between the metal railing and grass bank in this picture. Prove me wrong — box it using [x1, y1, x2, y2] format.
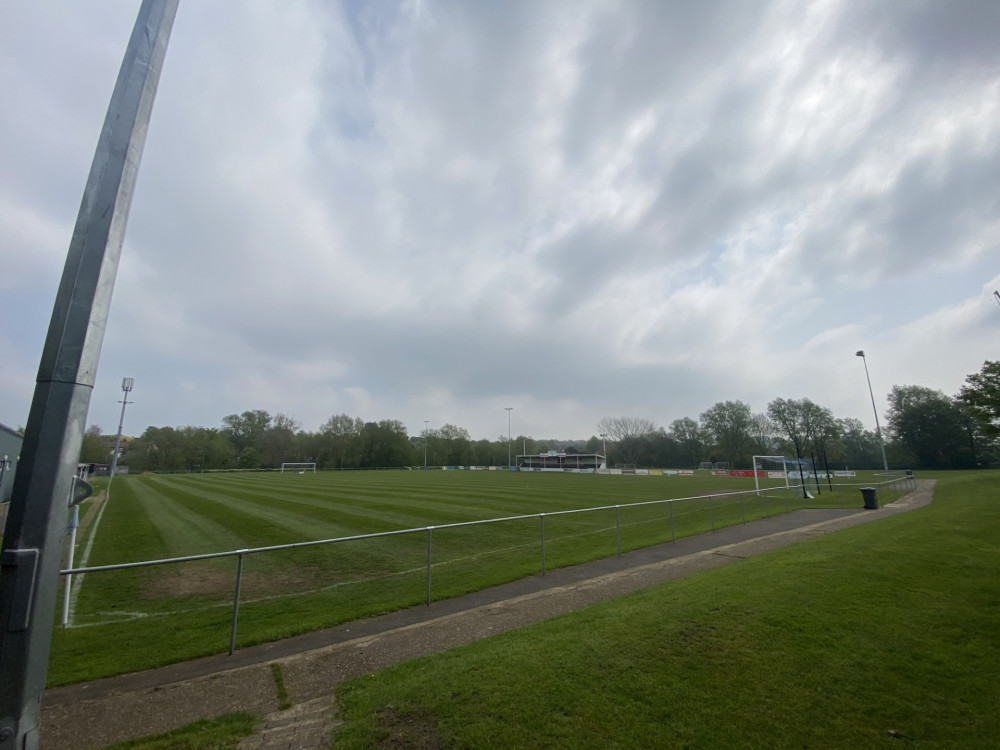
[41, 480, 934, 750]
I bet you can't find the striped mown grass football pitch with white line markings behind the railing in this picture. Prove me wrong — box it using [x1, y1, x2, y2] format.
[49, 471, 898, 685]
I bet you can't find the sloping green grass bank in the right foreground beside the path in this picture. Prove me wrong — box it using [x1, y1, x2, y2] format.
[337, 472, 1000, 748]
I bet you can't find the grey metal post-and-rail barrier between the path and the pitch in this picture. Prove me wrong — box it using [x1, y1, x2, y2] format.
[52, 472, 916, 654]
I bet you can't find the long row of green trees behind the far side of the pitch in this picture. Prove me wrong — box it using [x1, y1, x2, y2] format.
[81, 361, 1000, 472]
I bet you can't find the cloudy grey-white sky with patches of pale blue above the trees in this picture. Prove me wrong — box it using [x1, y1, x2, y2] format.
[0, 0, 1000, 439]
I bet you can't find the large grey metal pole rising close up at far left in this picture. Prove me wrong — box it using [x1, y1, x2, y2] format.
[0, 0, 178, 750]
